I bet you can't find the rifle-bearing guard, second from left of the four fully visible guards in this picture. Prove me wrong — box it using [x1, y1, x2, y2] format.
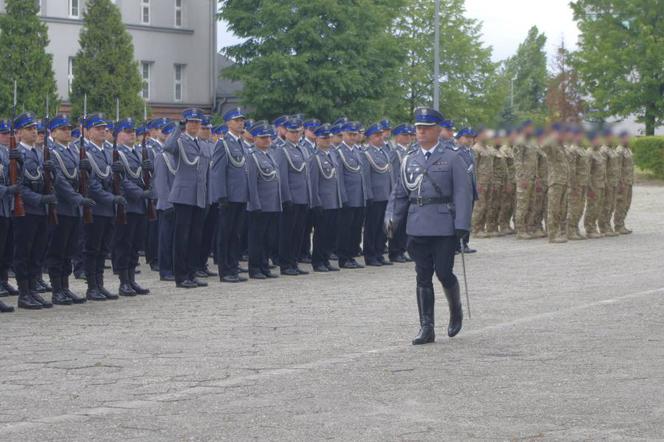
[45, 115, 96, 305]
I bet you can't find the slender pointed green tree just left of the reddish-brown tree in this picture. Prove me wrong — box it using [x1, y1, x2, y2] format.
[503, 26, 549, 123]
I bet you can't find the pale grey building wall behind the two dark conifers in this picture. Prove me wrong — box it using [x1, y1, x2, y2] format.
[0, 0, 217, 115]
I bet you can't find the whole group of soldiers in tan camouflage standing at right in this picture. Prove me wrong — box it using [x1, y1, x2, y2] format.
[462, 121, 634, 243]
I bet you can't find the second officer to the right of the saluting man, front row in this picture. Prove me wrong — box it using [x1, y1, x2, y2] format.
[247, 121, 288, 279]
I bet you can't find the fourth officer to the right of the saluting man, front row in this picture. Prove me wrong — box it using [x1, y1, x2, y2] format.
[308, 124, 345, 272]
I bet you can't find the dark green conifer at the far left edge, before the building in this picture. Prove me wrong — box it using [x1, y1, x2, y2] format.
[0, 0, 58, 115]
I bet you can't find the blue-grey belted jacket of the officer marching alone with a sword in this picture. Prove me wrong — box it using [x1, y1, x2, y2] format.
[385, 144, 473, 236]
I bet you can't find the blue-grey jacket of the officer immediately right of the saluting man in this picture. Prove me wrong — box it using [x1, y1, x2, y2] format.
[210, 133, 249, 203]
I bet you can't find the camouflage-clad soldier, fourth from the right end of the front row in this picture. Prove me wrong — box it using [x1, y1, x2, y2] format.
[567, 128, 590, 240]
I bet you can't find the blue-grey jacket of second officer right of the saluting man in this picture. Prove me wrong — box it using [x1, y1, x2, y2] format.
[247, 148, 288, 212]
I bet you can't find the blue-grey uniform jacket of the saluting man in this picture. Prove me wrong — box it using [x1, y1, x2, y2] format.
[164, 126, 210, 208]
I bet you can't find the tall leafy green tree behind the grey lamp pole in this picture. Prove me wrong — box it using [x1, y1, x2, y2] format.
[394, 0, 506, 125]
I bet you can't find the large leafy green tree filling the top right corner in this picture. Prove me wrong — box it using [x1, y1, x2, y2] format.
[571, 0, 664, 135]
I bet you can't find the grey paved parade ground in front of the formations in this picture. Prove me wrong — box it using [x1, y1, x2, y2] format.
[0, 187, 664, 441]
